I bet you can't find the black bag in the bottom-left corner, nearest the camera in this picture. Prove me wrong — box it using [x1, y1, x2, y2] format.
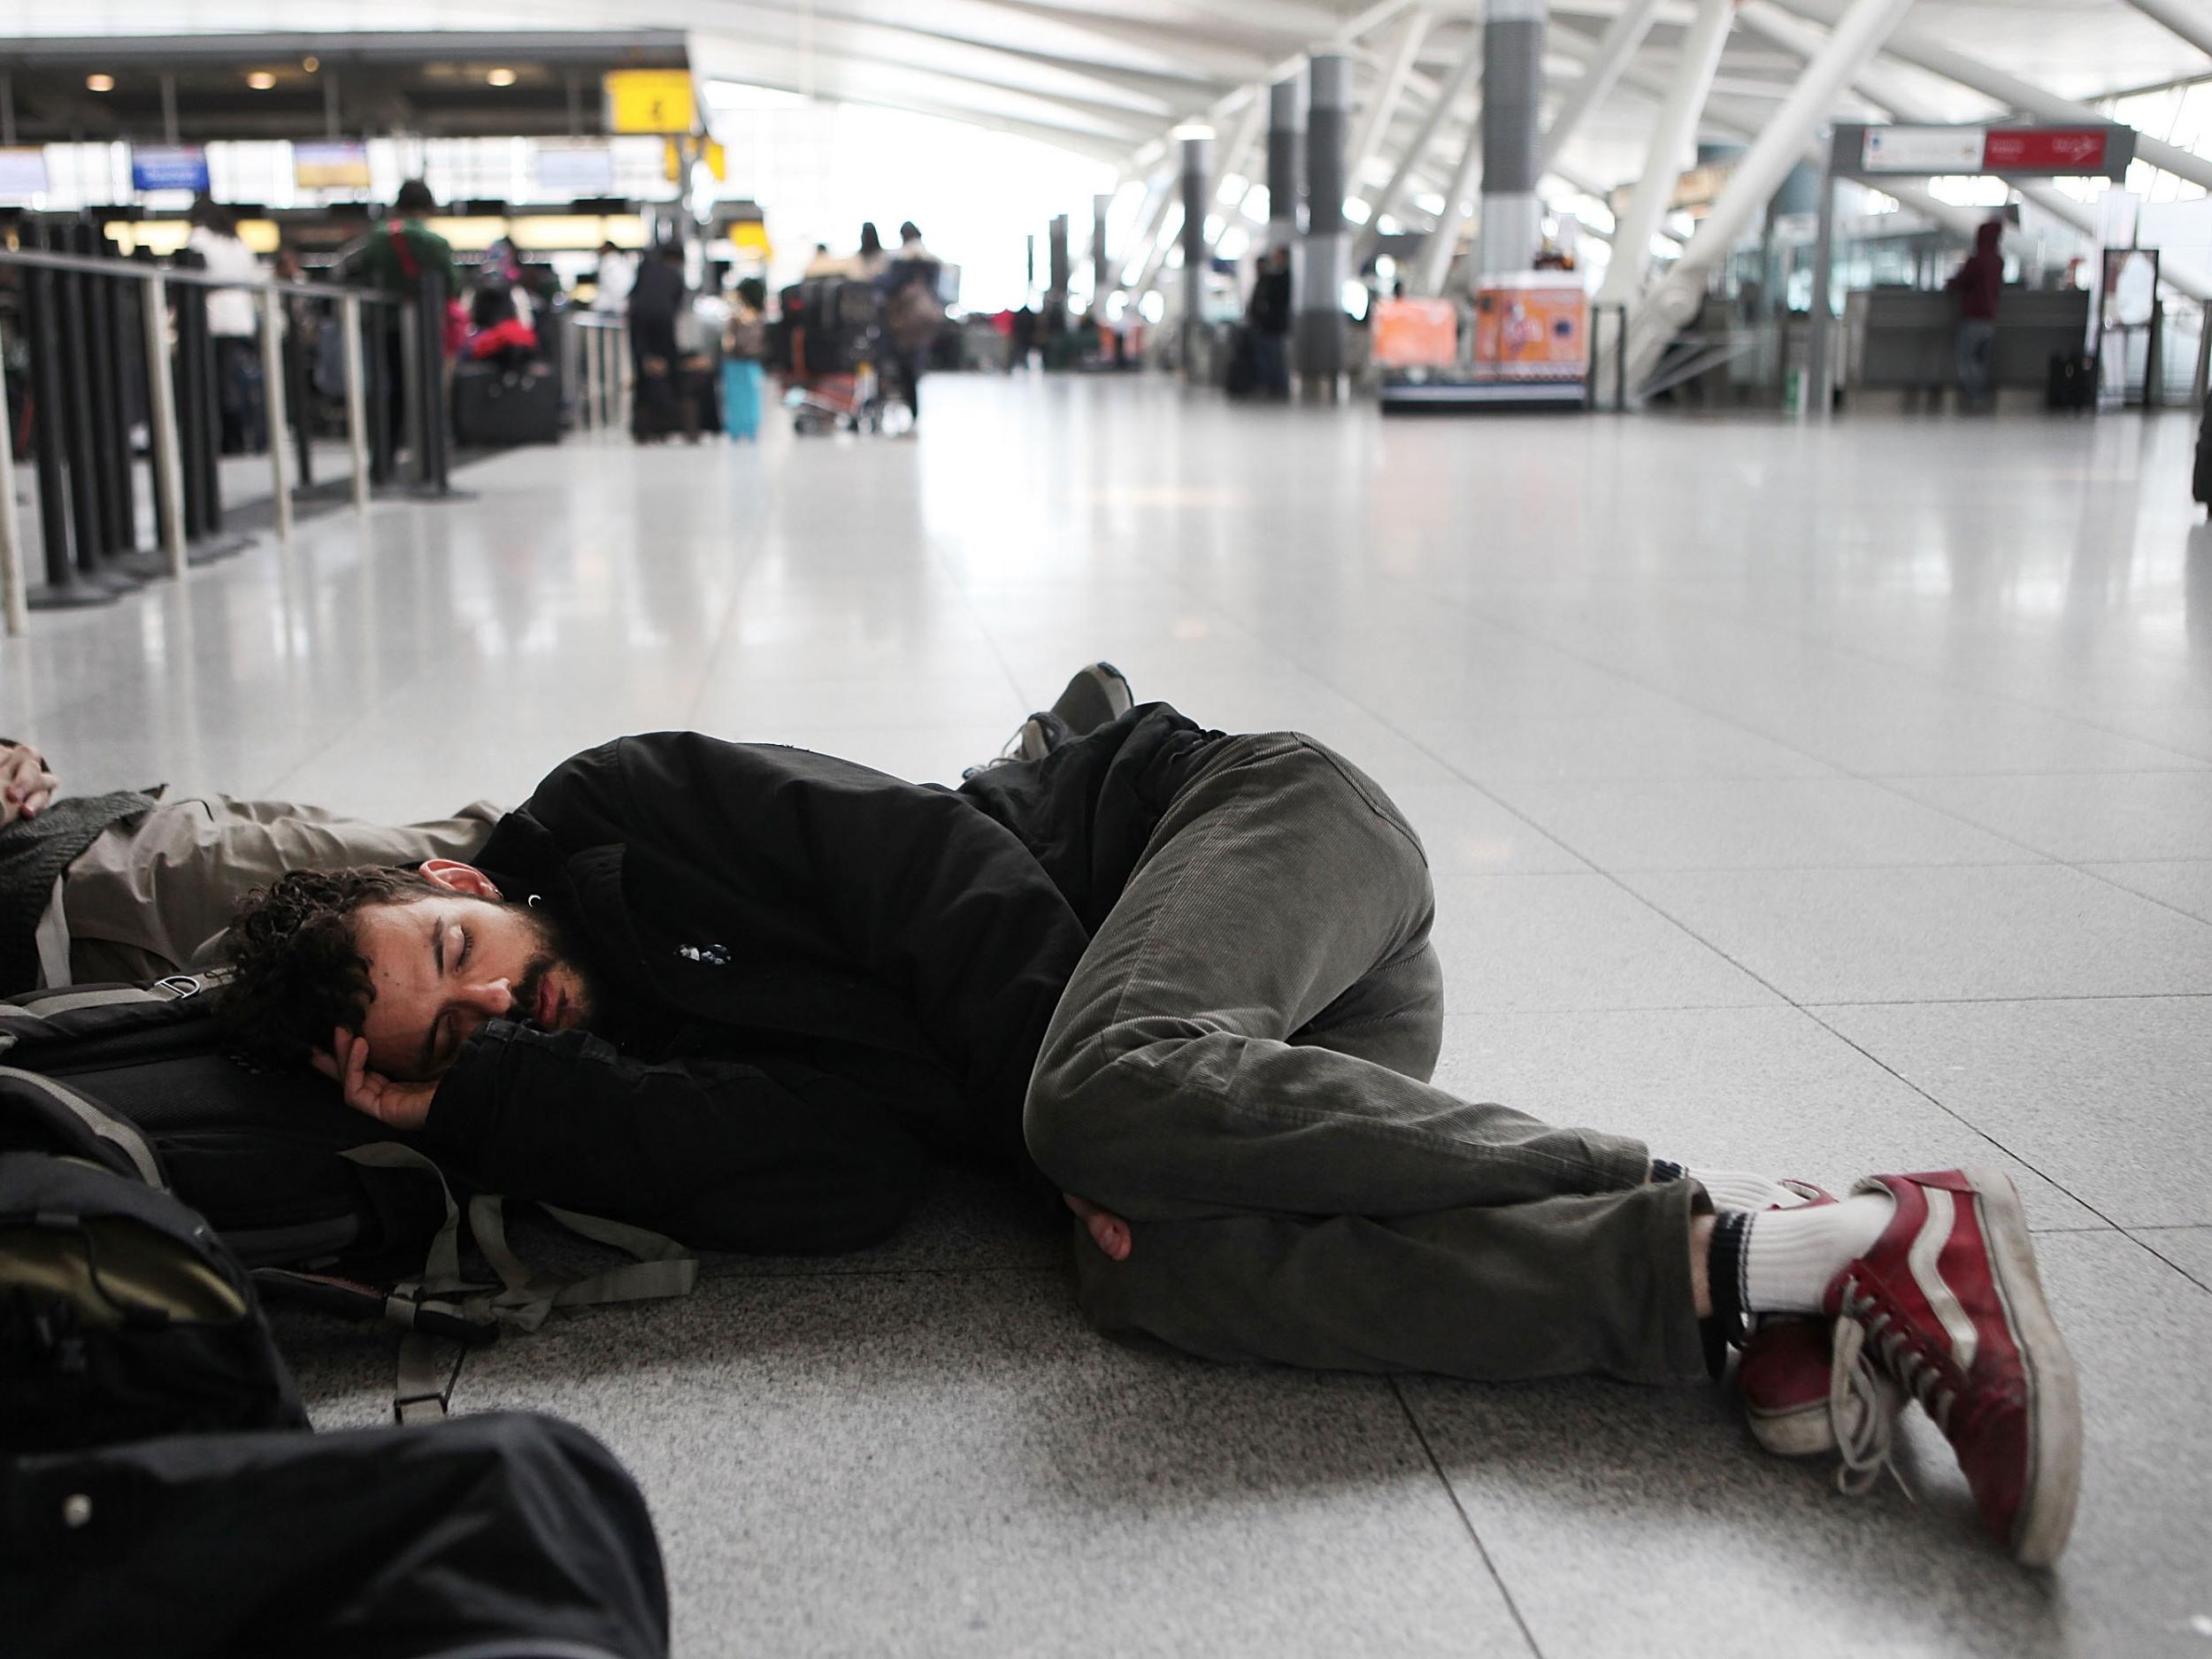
[0, 1411, 668, 1659]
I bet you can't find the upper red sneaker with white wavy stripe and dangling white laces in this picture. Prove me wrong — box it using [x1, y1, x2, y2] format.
[1827, 1171, 2082, 1566]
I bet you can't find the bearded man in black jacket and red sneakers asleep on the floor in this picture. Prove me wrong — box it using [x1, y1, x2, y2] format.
[0, 664, 2082, 1564]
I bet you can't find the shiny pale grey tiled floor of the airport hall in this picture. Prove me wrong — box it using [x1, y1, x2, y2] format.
[17, 379, 2212, 1659]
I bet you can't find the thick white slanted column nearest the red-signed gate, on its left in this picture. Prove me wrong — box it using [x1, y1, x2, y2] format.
[1615, 0, 1914, 388]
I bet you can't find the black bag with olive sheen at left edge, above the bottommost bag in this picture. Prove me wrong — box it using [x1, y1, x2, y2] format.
[0, 1066, 308, 1454]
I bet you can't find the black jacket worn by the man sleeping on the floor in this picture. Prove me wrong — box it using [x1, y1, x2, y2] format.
[425, 703, 1219, 1250]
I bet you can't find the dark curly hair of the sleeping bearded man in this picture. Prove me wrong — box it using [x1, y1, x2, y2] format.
[217, 870, 445, 1064]
